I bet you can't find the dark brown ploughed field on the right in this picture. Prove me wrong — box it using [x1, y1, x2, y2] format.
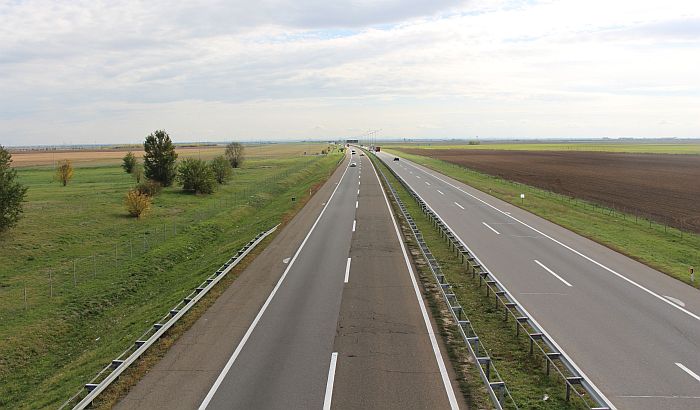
[400, 148, 700, 233]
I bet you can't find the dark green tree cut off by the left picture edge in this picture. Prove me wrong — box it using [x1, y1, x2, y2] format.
[0, 145, 27, 232]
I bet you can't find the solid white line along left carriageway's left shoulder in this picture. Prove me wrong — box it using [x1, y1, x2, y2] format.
[199, 159, 350, 410]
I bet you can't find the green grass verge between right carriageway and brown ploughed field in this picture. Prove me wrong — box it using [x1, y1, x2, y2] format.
[388, 150, 700, 287]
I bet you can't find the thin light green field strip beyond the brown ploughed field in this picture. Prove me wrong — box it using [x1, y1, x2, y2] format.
[383, 140, 700, 155]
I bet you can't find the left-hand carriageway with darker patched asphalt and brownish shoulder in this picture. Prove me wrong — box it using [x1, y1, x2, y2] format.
[117, 155, 462, 409]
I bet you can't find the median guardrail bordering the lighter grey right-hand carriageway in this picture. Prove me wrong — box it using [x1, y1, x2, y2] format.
[375, 156, 611, 410]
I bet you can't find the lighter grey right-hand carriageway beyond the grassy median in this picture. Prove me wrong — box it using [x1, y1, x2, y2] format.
[378, 152, 700, 410]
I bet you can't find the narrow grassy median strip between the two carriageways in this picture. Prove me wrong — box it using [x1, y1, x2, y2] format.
[375, 155, 588, 409]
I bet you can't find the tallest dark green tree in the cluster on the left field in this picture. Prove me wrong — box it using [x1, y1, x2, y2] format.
[143, 130, 177, 186]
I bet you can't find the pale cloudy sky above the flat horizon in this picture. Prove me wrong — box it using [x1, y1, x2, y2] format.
[0, 0, 700, 145]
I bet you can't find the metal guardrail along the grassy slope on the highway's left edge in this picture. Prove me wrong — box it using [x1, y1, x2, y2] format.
[60, 224, 279, 410]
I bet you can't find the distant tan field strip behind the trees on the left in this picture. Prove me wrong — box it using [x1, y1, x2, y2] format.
[12, 143, 327, 168]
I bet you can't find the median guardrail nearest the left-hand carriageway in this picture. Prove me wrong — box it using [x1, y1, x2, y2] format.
[372, 161, 518, 410]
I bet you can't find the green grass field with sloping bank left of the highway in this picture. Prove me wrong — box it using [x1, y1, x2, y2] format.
[0, 145, 341, 408]
